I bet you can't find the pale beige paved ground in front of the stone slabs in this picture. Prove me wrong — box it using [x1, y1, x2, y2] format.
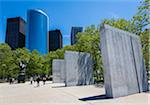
[0, 82, 150, 105]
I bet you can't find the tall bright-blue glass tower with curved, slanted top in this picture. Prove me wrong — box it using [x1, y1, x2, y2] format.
[26, 10, 49, 54]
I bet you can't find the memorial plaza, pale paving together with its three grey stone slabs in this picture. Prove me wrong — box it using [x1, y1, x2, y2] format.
[0, 25, 150, 105]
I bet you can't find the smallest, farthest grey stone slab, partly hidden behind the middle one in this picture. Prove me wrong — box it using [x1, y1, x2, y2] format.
[52, 59, 65, 83]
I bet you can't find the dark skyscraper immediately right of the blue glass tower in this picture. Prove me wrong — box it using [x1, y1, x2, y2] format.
[49, 30, 62, 51]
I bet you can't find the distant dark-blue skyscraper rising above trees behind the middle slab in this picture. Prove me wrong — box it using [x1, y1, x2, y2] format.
[71, 27, 83, 45]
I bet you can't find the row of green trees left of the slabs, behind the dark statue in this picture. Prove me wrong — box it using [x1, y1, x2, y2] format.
[0, 44, 50, 79]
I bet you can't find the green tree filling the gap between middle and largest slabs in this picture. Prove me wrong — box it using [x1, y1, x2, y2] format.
[75, 25, 103, 82]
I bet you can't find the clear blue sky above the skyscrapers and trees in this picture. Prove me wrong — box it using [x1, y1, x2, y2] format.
[0, 0, 140, 45]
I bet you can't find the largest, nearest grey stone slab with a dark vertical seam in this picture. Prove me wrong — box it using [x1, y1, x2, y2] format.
[100, 25, 148, 98]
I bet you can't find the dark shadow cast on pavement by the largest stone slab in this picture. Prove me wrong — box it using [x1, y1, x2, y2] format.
[79, 94, 112, 101]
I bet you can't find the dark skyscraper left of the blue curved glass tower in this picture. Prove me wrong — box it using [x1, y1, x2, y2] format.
[5, 17, 26, 50]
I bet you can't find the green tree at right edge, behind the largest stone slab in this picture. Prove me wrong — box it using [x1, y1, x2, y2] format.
[132, 0, 150, 78]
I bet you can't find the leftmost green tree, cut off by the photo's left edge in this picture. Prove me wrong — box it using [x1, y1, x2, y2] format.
[0, 44, 19, 78]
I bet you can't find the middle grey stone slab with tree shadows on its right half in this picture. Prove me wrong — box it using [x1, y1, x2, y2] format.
[65, 51, 93, 86]
